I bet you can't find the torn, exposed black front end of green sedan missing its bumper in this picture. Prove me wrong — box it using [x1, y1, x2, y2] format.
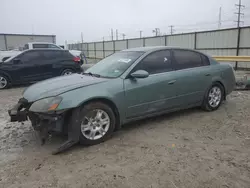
[8, 98, 79, 154]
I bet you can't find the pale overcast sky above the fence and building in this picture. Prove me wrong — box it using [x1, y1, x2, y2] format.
[0, 0, 250, 44]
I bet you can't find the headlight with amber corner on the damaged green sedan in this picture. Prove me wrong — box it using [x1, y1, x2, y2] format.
[29, 97, 62, 112]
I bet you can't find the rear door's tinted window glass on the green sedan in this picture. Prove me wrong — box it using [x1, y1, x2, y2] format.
[173, 50, 202, 70]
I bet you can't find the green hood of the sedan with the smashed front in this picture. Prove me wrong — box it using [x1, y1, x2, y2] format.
[23, 74, 107, 102]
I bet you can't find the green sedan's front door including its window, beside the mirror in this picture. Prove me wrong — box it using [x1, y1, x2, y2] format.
[124, 50, 176, 119]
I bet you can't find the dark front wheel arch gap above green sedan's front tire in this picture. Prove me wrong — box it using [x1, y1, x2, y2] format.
[78, 97, 121, 130]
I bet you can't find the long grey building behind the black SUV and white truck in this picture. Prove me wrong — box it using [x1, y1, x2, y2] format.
[0, 33, 56, 50]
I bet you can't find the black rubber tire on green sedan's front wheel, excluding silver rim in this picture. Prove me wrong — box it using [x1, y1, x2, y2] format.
[79, 102, 116, 146]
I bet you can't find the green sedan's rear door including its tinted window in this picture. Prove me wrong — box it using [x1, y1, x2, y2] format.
[173, 49, 212, 107]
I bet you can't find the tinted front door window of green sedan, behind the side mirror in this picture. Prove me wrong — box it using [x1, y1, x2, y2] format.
[132, 50, 172, 74]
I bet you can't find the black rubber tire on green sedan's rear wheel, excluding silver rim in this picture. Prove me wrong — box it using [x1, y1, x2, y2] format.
[201, 82, 225, 111]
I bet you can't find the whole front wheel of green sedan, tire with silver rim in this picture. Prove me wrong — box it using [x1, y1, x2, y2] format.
[79, 102, 116, 146]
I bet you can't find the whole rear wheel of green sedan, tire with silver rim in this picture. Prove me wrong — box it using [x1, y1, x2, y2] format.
[202, 83, 225, 111]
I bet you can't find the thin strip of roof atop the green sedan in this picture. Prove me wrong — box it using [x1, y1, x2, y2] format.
[122, 46, 201, 53]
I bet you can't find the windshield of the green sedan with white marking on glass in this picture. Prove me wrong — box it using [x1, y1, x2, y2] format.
[85, 51, 144, 78]
